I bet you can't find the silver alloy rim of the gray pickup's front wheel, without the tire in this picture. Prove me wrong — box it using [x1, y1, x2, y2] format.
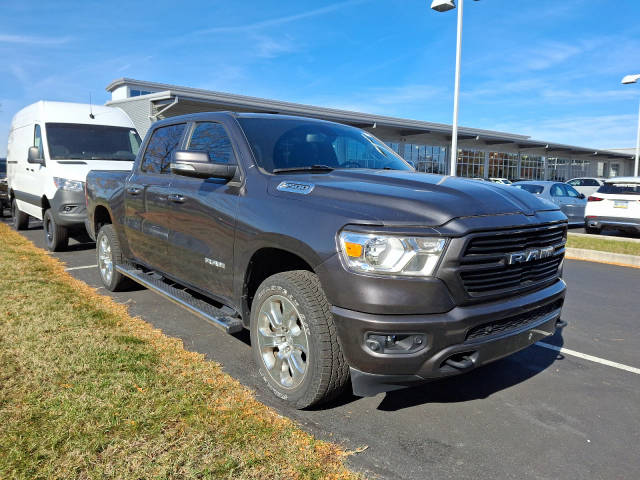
[257, 295, 309, 389]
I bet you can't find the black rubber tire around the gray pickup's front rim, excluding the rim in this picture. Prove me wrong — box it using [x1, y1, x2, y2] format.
[251, 270, 349, 409]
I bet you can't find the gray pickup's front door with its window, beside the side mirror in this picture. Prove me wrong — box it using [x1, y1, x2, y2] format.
[169, 121, 240, 299]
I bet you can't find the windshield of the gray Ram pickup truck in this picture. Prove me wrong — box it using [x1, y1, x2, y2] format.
[238, 117, 413, 173]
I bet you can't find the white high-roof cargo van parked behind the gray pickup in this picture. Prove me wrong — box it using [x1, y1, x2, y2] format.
[7, 101, 140, 251]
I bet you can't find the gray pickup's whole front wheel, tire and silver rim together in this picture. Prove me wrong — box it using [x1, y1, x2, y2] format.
[251, 270, 349, 408]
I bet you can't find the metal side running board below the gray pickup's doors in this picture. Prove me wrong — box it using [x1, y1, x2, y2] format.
[116, 265, 243, 333]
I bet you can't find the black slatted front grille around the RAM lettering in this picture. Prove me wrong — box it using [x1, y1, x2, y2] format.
[459, 224, 567, 297]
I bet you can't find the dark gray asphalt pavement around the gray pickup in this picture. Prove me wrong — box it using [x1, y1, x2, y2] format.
[5, 219, 640, 480]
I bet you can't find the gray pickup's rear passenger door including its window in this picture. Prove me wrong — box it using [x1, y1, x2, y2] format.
[124, 122, 186, 273]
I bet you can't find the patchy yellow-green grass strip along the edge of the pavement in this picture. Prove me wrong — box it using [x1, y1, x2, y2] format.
[0, 224, 360, 479]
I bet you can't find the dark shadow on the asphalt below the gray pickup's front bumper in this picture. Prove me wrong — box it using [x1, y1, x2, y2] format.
[378, 330, 564, 411]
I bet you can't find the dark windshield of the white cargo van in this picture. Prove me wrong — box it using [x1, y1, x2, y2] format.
[46, 123, 140, 161]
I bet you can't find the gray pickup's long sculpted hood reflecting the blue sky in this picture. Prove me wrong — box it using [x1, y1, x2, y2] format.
[270, 169, 558, 226]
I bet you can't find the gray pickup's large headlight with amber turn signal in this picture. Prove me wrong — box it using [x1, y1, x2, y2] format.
[340, 230, 447, 277]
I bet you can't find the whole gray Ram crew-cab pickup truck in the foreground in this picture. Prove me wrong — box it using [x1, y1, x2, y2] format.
[86, 112, 567, 408]
